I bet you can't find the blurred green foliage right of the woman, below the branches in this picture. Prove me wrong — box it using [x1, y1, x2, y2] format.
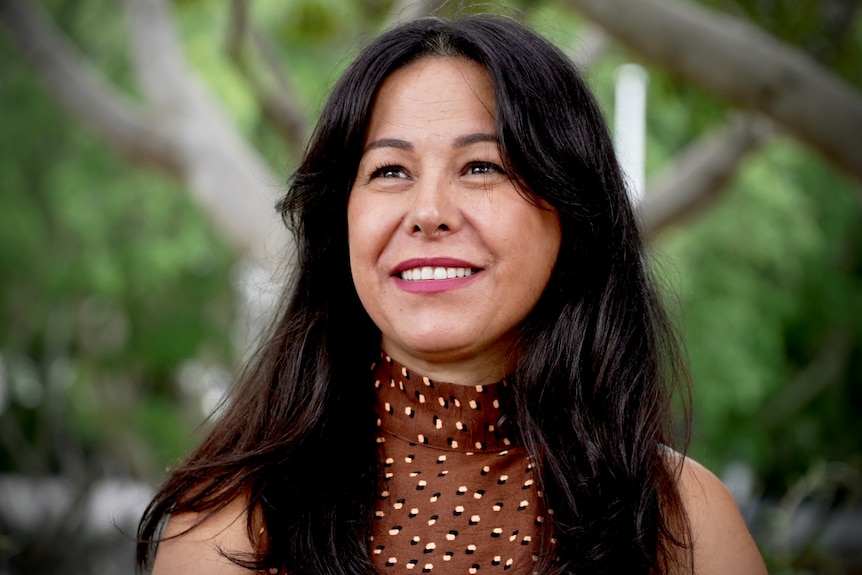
[658, 142, 862, 495]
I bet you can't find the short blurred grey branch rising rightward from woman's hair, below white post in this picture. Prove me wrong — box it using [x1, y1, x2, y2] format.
[640, 117, 772, 236]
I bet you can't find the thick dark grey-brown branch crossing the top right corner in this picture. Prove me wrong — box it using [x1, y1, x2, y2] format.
[567, 0, 862, 181]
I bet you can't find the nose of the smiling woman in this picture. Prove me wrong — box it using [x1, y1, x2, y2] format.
[405, 175, 462, 237]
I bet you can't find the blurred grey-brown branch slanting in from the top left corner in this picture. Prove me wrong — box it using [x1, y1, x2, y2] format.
[0, 0, 181, 175]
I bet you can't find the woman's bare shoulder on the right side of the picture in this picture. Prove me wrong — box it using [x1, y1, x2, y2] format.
[676, 454, 766, 575]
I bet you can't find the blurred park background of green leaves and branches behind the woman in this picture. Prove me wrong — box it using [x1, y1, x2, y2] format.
[0, 0, 862, 575]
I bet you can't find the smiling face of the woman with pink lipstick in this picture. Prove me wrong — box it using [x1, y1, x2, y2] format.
[347, 58, 561, 384]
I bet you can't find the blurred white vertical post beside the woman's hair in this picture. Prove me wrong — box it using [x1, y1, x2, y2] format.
[614, 64, 649, 204]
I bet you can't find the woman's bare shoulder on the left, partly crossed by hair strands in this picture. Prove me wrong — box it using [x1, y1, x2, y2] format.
[153, 498, 253, 575]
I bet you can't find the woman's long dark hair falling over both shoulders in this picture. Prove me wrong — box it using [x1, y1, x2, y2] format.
[137, 16, 691, 574]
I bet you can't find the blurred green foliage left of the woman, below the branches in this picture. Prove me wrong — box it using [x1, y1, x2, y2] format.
[0, 31, 235, 477]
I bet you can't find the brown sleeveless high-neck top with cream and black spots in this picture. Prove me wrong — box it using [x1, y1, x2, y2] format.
[370, 354, 555, 575]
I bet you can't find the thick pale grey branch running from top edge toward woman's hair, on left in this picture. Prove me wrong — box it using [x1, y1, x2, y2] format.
[125, 0, 289, 270]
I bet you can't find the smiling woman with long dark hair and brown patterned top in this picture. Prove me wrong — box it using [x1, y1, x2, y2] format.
[138, 16, 765, 575]
